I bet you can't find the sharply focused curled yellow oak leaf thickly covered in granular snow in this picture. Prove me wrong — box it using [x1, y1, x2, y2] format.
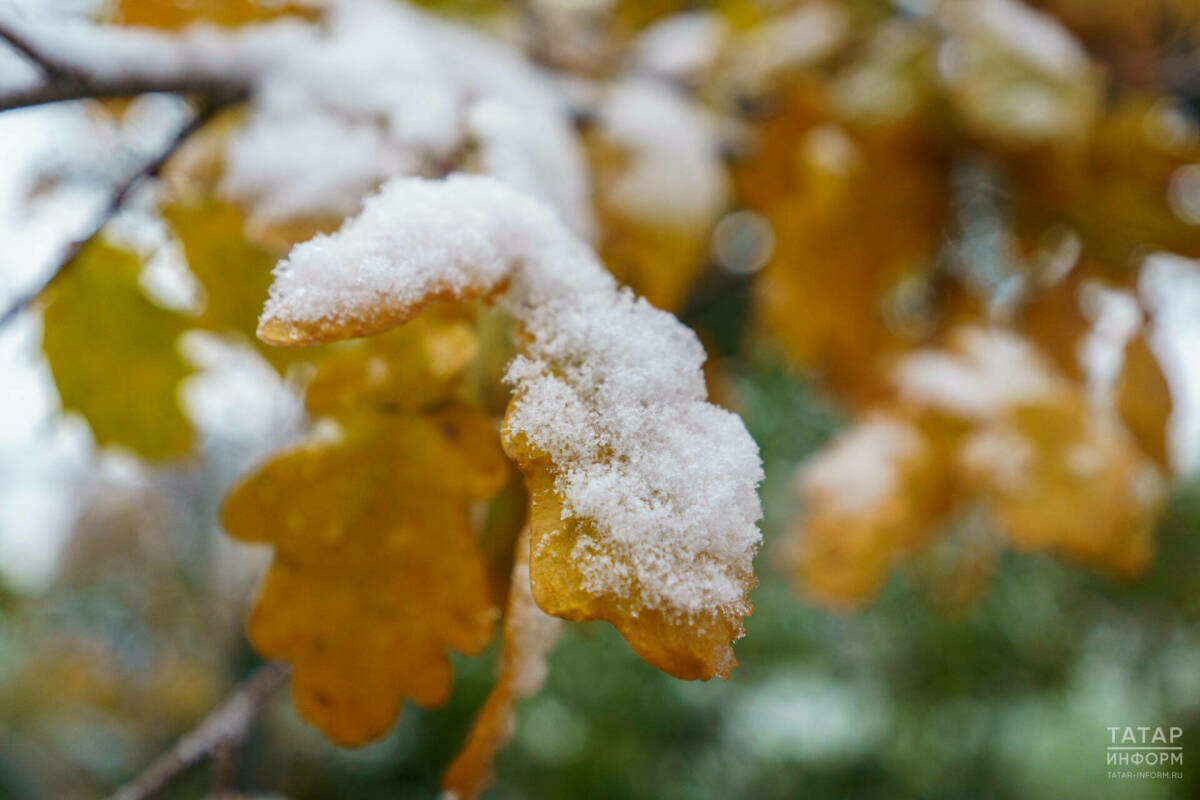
[259, 175, 762, 679]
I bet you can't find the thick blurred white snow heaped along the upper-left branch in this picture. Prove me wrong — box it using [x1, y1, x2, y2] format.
[0, 0, 590, 234]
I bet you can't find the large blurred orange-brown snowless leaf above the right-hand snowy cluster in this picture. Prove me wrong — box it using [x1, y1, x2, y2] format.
[738, 82, 946, 398]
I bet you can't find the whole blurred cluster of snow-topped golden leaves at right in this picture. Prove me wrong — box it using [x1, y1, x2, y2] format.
[796, 327, 1165, 607]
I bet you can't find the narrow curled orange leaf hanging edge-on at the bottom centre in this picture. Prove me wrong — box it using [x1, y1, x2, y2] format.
[442, 533, 563, 800]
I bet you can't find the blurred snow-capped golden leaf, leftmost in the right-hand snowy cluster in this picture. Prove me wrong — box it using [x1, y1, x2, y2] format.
[796, 413, 946, 607]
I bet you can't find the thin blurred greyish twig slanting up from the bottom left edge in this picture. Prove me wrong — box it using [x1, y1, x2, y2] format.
[109, 662, 288, 800]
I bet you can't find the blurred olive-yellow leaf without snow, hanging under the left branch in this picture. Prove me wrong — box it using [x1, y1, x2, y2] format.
[42, 239, 193, 458]
